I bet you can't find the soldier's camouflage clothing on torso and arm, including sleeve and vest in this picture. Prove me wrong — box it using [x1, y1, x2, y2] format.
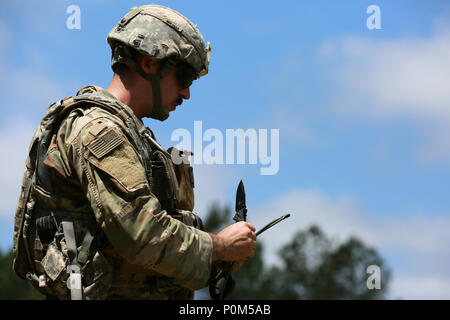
[13, 5, 212, 299]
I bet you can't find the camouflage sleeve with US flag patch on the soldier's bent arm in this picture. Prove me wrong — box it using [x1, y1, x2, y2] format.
[62, 111, 212, 290]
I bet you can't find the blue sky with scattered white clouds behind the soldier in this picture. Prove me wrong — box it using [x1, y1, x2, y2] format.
[0, 0, 450, 299]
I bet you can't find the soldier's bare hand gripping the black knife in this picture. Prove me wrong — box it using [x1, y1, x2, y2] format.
[210, 221, 256, 269]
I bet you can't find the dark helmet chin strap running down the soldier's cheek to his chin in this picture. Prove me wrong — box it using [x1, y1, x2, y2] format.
[112, 45, 176, 121]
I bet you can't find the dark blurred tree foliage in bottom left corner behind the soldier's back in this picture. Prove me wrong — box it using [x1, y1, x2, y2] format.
[0, 250, 43, 300]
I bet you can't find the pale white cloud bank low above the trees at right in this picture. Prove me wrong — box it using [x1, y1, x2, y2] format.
[251, 189, 450, 298]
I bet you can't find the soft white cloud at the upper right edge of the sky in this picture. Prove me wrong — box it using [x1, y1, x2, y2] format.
[330, 32, 450, 119]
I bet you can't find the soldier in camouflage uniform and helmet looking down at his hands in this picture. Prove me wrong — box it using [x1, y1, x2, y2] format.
[13, 5, 256, 299]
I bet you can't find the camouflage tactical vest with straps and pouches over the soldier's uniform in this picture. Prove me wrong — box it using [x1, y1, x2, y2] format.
[13, 90, 203, 299]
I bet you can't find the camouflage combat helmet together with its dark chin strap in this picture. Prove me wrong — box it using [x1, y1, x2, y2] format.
[107, 4, 211, 121]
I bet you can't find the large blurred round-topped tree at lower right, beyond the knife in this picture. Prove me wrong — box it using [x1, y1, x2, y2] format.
[269, 226, 390, 299]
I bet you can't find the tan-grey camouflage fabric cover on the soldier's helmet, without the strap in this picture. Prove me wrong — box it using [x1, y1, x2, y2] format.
[107, 4, 211, 77]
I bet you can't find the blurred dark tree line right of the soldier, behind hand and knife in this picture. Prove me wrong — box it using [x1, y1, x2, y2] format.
[197, 204, 390, 299]
